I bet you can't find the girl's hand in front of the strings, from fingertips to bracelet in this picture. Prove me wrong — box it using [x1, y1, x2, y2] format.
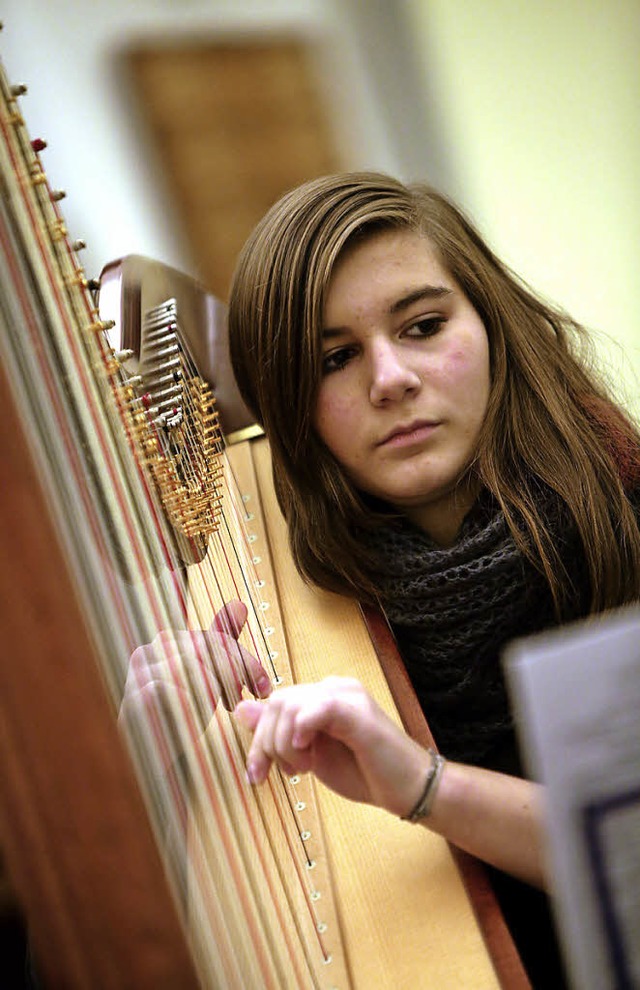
[235, 677, 426, 815]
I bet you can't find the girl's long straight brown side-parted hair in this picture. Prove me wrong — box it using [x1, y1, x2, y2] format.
[229, 173, 640, 616]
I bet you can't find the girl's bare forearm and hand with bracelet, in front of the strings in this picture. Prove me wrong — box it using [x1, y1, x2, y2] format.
[236, 677, 547, 888]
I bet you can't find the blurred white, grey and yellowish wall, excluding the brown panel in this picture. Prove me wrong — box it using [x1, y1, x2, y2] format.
[1, 0, 640, 415]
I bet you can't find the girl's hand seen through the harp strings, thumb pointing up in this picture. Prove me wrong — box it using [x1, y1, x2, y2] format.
[119, 601, 271, 759]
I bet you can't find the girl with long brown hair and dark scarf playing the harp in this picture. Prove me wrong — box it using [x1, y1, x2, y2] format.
[229, 173, 640, 987]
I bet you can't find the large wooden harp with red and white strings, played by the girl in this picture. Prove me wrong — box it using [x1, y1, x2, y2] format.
[0, 52, 527, 990]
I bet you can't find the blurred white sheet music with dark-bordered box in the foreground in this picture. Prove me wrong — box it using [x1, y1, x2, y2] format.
[505, 609, 640, 990]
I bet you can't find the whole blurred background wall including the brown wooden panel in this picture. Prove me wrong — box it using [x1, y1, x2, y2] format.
[5, 0, 640, 414]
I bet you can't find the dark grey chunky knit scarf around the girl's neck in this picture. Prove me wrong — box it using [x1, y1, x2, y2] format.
[367, 493, 586, 766]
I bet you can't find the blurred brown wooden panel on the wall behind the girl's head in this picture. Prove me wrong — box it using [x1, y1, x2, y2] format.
[127, 36, 341, 299]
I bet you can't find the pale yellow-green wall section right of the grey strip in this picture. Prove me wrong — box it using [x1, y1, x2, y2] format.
[407, 0, 640, 414]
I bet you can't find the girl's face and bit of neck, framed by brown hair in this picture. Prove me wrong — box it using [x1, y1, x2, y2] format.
[314, 230, 490, 545]
